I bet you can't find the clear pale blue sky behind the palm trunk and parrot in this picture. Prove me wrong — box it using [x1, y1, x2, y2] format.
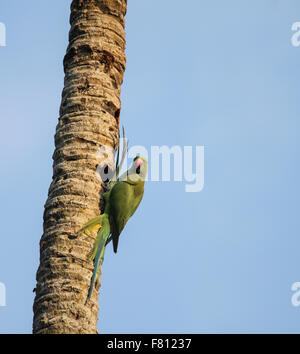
[0, 0, 300, 333]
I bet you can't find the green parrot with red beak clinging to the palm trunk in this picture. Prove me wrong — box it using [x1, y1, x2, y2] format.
[78, 156, 148, 301]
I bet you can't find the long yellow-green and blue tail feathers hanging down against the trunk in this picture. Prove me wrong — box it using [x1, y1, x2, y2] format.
[87, 214, 110, 301]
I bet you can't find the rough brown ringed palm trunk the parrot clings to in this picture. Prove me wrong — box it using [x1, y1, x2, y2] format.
[33, 0, 127, 334]
